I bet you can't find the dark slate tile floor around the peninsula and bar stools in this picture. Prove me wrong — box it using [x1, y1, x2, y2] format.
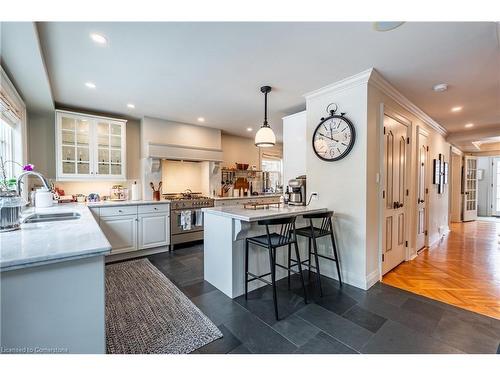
[148, 244, 500, 354]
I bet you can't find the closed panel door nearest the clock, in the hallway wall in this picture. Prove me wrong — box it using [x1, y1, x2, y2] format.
[382, 116, 408, 274]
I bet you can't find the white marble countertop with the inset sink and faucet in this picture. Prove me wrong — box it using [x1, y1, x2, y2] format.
[0, 203, 111, 272]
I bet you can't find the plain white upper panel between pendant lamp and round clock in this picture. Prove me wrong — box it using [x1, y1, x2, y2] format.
[283, 111, 307, 186]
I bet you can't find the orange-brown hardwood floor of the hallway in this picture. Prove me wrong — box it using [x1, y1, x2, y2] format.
[383, 221, 500, 319]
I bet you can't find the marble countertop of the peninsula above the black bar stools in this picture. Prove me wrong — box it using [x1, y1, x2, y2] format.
[202, 205, 327, 222]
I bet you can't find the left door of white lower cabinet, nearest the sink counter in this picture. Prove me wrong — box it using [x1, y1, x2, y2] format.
[99, 215, 137, 254]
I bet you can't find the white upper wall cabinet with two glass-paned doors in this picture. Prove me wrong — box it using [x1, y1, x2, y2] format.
[56, 111, 127, 181]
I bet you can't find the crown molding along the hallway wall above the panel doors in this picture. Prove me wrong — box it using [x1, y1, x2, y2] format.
[369, 69, 448, 136]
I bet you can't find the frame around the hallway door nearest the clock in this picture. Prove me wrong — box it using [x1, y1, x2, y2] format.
[377, 103, 413, 281]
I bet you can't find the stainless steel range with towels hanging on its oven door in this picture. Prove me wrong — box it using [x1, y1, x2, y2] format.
[163, 190, 214, 248]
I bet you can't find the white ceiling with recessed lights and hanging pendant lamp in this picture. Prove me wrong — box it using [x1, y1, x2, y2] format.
[38, 22, 500, 142]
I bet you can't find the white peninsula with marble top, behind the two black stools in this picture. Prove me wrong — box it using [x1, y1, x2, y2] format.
[203, 206, 327, 298]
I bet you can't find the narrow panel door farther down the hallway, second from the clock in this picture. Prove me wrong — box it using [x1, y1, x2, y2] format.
[415, 132, 429, 251]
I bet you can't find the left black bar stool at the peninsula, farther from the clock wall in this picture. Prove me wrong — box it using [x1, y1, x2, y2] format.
[245, 217, 307, 320]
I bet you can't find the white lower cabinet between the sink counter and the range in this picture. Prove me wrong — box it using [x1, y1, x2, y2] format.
[92, 204, 170, 255]
